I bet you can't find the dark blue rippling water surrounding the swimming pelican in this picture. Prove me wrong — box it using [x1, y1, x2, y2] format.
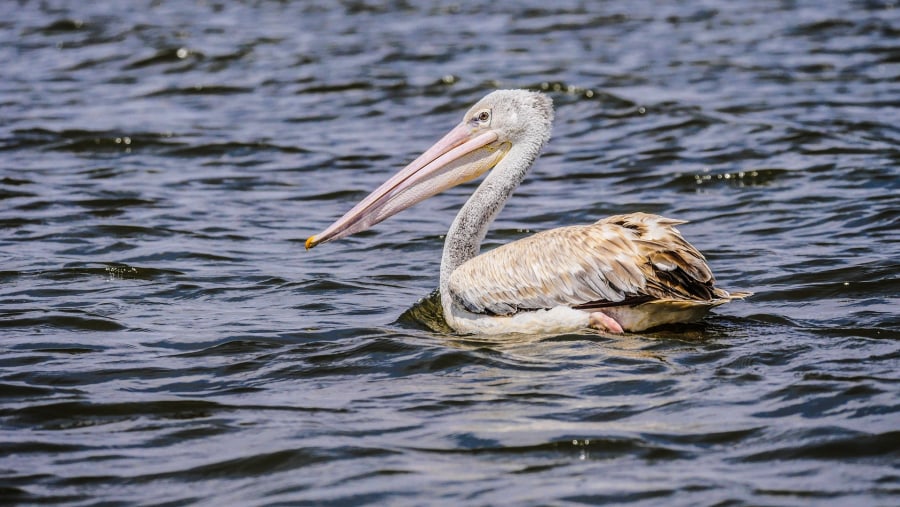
[0, 1, 900, 505]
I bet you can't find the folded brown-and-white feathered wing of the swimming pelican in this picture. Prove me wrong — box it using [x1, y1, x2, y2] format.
[449, 213, 728, 315]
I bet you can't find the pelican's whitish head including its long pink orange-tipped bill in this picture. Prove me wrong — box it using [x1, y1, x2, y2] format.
[306, 90, 553, 249]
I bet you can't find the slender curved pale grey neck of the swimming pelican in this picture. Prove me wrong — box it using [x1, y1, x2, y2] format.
[440, 143, 543, 299]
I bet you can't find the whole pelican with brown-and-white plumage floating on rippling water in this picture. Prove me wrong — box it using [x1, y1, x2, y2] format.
[306, 90, 750, 334]
